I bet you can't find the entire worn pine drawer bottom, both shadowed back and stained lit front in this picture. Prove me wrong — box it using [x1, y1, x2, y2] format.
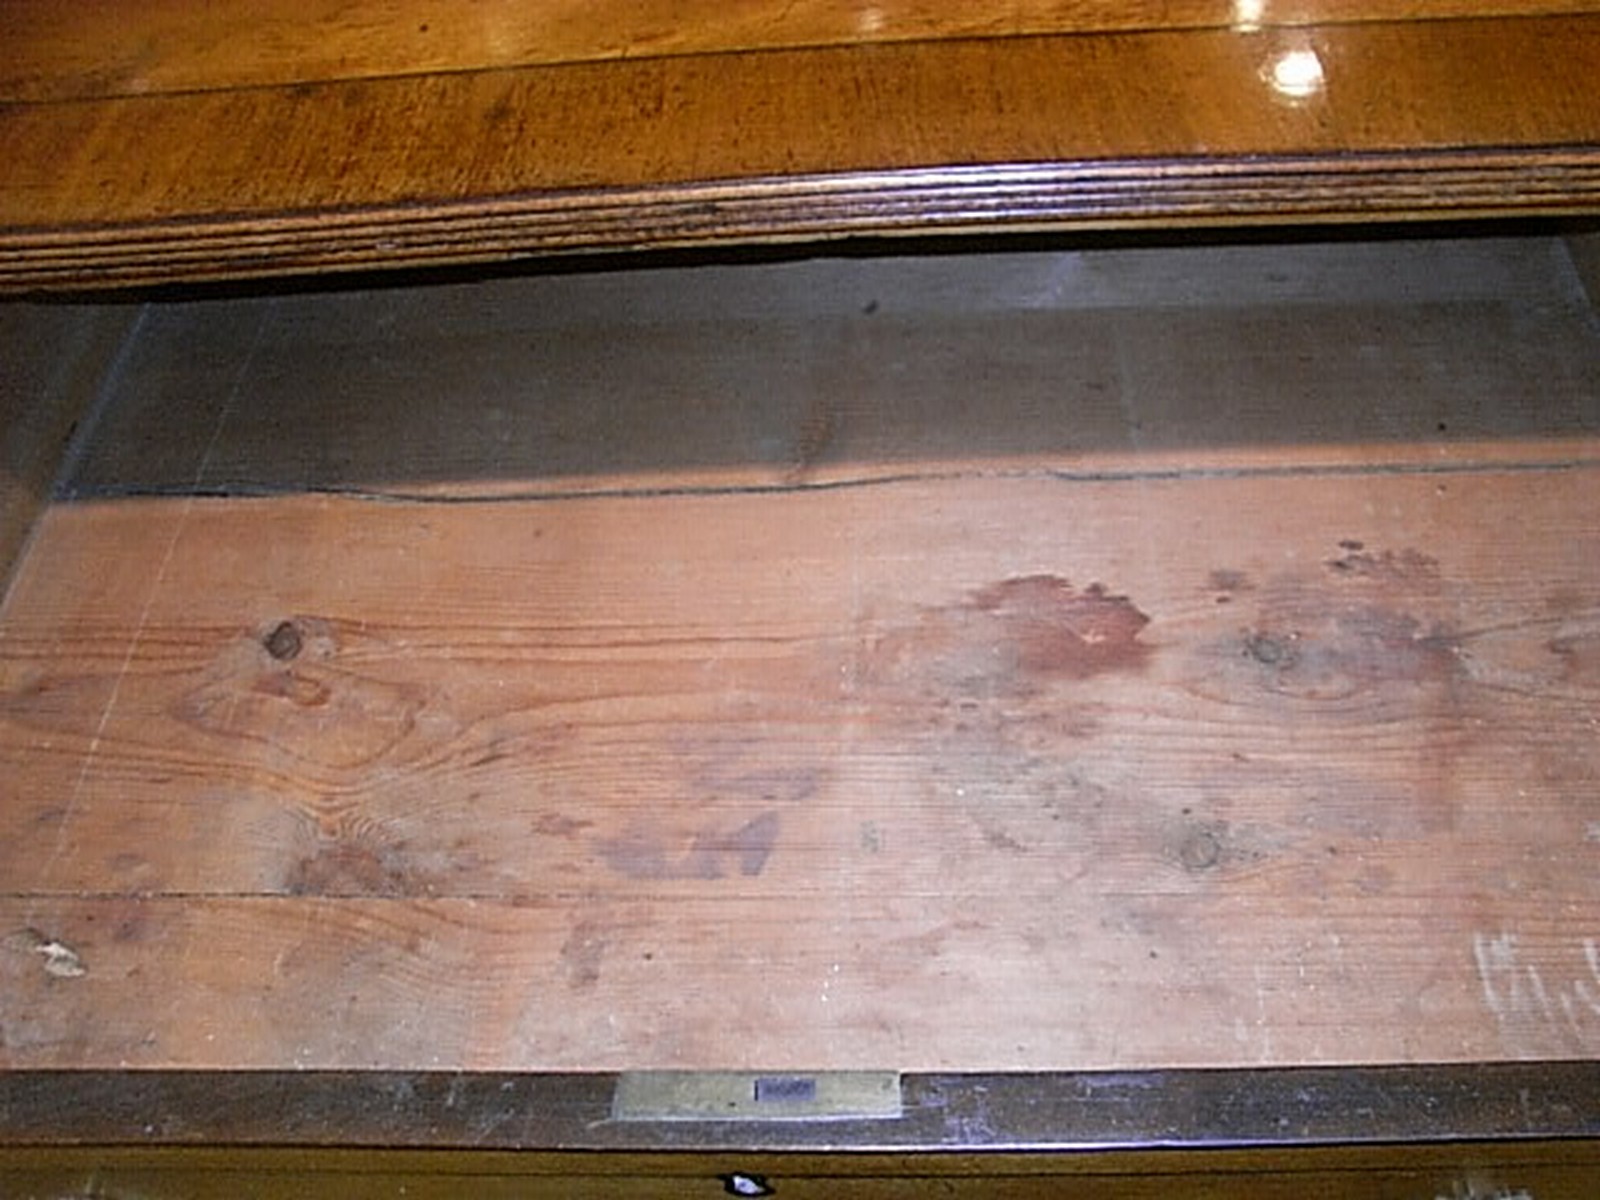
[0, 242, 1600, 1070]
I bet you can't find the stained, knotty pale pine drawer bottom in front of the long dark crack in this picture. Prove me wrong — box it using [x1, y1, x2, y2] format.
[0, 467, 1600, 1069]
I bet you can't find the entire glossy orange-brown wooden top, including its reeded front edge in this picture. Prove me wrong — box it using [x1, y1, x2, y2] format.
[0, 0, 1600, 291]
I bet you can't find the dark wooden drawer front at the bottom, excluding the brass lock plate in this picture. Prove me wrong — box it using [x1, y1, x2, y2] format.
[0, 1062, 1600, 1200]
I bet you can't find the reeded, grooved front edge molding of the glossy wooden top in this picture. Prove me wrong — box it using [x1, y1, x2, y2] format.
[0, 147, 1600, 291]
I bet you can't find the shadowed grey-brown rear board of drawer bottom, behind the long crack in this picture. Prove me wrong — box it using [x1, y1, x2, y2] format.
[50, 226, 1600, 496]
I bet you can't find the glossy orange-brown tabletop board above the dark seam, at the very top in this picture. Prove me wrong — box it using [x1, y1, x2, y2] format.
[0, 0, 1595, 102]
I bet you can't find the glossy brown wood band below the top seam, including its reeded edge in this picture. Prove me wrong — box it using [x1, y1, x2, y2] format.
[0, 16, 1600, 293]
